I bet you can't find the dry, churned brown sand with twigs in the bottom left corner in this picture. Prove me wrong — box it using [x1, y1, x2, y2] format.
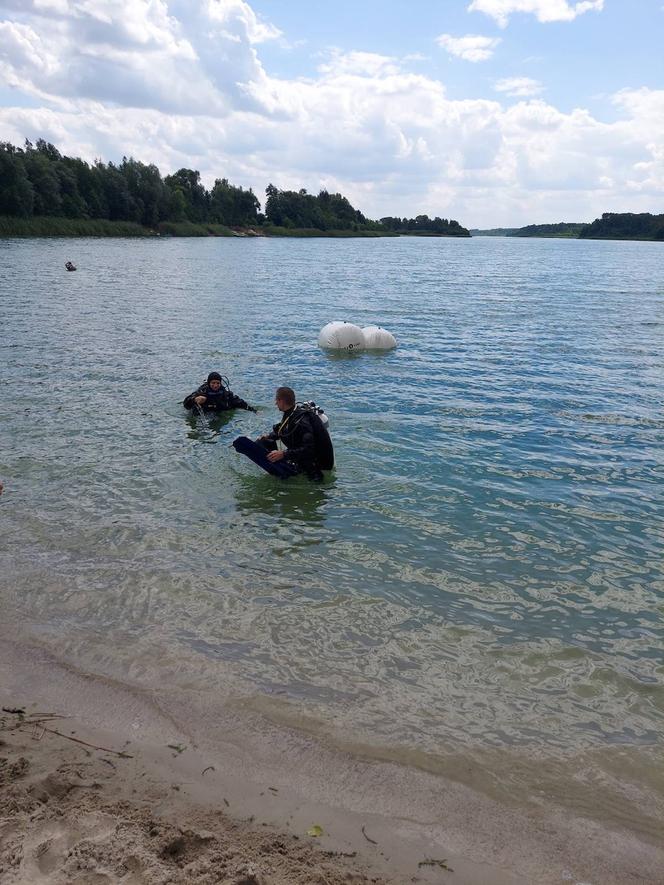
[0, 713, 382, 885]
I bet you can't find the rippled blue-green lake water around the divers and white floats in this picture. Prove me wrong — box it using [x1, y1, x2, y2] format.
[0, 238, 664, 831]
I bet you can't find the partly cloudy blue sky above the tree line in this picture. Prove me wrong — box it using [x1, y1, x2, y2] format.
[0, 0, 664, 228]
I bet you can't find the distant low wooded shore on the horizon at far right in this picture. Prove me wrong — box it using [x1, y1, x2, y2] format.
[470, 212, 664, 241]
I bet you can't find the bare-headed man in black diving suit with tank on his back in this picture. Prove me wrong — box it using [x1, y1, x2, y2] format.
[233, 387, 334, 481]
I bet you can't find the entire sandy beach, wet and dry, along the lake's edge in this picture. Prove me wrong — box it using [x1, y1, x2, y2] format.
[0, 641, 664, 885]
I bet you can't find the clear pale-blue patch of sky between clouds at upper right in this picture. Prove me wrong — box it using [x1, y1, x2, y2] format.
[252, 0, 664, 118]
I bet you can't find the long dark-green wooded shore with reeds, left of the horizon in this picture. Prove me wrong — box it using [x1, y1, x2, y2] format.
[0, 139, 470, 237]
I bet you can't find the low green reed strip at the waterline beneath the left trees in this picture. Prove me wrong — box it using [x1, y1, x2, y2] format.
[0, 216, 470, 239]
